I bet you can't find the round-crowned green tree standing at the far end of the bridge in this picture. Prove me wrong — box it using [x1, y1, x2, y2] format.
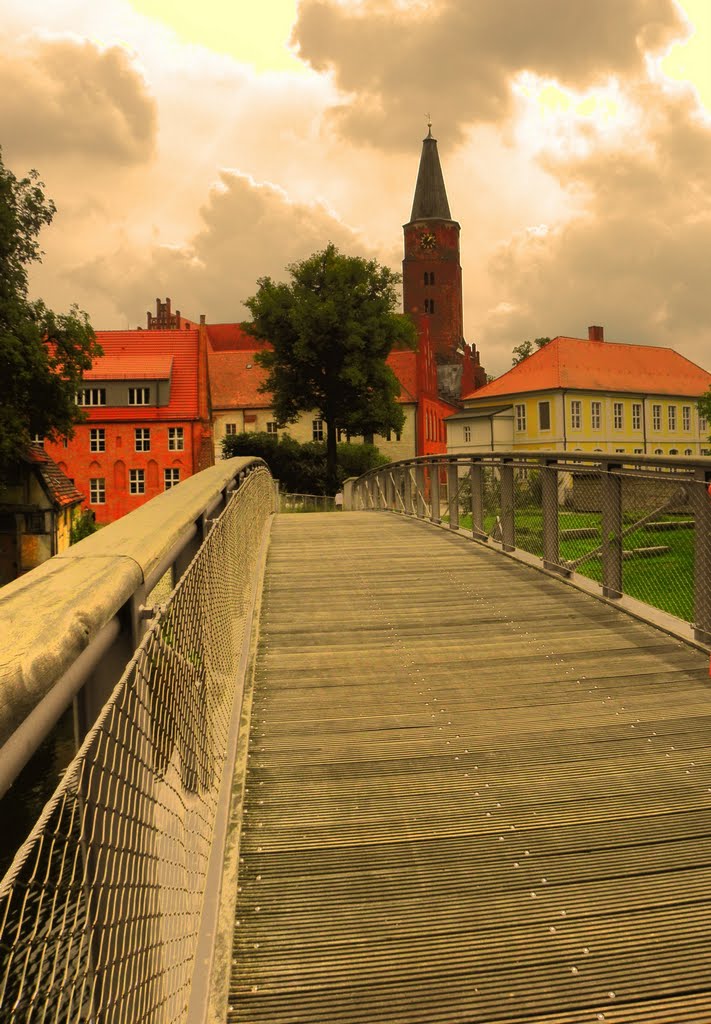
[245, 244, 416, 490]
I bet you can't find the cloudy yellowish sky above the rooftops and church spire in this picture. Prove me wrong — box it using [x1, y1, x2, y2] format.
[0, 0, 711, 374]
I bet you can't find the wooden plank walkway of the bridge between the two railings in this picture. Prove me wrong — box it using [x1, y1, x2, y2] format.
[227, 513, 711, 1024]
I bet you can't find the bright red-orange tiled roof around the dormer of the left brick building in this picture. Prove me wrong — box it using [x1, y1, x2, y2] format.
[86, 329, 200, 420]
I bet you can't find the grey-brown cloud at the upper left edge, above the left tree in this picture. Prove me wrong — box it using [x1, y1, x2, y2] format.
[0, 38, 156, 164]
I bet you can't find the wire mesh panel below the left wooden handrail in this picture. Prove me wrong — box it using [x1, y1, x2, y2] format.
[0, 469, 274, 1024]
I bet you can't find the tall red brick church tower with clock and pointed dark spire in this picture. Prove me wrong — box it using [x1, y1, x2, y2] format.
[403, 123, 487, 401]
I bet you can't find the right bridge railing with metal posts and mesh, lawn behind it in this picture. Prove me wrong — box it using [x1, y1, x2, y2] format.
[345, 452, 711, 645]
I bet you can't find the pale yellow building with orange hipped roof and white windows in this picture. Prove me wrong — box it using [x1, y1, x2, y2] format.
[447, 327, 711, 456]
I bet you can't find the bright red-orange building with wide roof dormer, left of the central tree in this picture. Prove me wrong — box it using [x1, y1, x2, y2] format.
[46, 319, 213, 523]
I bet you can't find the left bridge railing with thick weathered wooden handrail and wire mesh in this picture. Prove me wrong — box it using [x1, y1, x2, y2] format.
[0, 459, 275, 1024]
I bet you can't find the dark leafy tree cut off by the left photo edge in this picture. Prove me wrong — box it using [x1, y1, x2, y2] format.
[0, 151, 101, 477]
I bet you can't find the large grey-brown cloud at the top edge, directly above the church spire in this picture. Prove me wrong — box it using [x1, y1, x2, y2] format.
[293, 0, 684, 148]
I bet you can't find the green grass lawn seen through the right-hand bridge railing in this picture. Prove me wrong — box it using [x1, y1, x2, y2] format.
[459, 509, 694, 622]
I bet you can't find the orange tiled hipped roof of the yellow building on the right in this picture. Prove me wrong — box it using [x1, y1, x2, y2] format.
[464, 337, 711, 399]
